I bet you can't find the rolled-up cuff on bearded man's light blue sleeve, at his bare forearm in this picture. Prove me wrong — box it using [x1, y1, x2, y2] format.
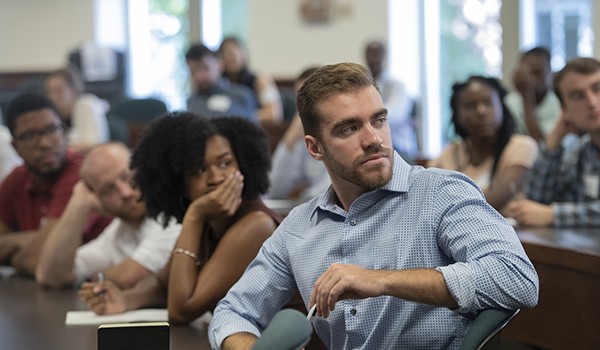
[436, 262, 475, 313]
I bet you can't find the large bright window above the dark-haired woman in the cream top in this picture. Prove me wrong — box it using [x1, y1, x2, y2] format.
[388, 0, 502, 158]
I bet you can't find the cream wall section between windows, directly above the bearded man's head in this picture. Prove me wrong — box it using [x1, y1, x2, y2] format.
[248, 0, 387, 78]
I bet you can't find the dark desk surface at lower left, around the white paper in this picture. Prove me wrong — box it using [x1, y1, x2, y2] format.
[0, 276, 210, 350]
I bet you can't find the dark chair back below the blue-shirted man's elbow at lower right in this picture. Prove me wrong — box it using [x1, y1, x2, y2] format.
[460, 309, 520, 350]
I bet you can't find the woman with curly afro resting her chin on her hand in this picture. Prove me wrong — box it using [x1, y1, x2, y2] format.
[80, 113, 280, 324]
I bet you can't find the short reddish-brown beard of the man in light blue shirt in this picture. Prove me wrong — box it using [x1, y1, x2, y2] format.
[323, 147, 394, 192]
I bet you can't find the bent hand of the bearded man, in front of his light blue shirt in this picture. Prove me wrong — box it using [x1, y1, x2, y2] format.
[308, 264, 386, 317]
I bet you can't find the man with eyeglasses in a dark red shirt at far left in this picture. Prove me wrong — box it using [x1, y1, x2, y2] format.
[0, 94, 110, 275]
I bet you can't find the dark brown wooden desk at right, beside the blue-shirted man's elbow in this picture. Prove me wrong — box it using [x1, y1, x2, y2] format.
[502, 228, 600, 349]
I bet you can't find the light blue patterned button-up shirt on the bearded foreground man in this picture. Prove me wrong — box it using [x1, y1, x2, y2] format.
[209, 154, 538, 349]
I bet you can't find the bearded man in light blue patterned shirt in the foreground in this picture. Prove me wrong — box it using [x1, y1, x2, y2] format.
[209, 63, 538, 349]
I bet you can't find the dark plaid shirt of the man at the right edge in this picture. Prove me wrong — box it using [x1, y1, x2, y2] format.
[525, 135, 600, 227]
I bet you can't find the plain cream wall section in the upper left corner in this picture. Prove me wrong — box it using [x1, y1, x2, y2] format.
[0, 0, 94, 72]
